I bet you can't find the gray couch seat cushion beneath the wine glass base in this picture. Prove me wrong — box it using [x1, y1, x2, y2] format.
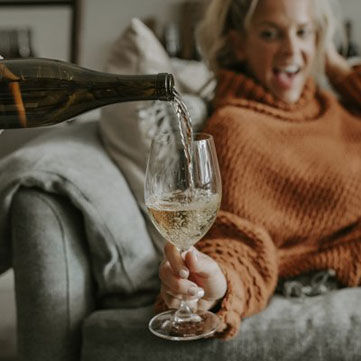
[82, 288, 361, 361]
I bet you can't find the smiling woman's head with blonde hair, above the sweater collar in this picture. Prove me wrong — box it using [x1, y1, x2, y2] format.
[198, 0, 336, 103]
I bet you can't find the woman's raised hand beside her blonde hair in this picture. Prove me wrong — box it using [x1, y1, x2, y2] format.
[325, 43, 352, 84]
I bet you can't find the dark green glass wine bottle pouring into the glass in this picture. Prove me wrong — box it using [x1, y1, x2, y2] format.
[0, 58, 174, 129]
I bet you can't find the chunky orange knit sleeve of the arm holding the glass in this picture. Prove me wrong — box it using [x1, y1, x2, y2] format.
[196, 211, 278, 339]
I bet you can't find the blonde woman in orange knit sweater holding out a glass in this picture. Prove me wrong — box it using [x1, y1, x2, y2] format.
[158, 0, 361, 339]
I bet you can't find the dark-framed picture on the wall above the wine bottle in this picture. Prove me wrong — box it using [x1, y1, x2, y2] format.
[0, 0, 81, 63]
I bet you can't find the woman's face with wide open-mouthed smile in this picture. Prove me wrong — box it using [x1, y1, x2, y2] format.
[234, 0, 317, 103]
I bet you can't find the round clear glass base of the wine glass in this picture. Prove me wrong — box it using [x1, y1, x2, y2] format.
[149, 310, 220, 341]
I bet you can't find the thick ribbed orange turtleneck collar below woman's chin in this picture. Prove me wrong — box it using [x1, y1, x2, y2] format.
[214, 70, 326, 121]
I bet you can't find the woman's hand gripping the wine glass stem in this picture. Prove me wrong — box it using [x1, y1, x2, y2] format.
[159, 243, 227, 310]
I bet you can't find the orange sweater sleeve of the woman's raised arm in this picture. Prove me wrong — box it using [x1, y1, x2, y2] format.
[333, 65, 361, 108]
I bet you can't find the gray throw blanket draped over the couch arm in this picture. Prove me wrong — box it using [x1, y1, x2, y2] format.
[0, 122, 158, 296]
